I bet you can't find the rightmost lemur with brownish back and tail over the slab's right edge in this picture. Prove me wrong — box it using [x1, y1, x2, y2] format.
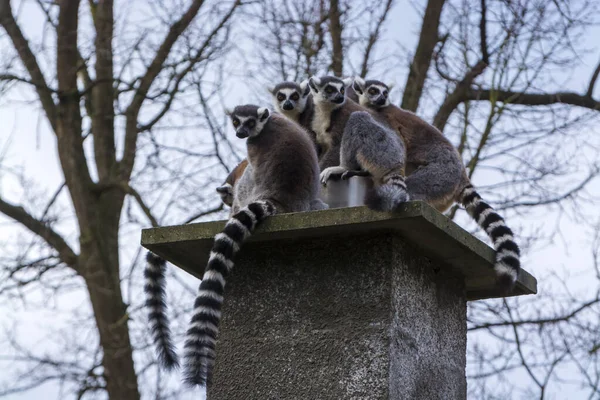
[354, 78, 521, 291]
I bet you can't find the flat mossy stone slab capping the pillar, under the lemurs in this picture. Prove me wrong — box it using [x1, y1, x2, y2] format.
[142, 201, 537, 300]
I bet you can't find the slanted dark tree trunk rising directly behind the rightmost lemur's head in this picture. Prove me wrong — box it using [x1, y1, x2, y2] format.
[402, 0, 446, 111]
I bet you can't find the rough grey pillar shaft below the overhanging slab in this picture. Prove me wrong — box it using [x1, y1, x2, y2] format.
[208, 233, 466, 400]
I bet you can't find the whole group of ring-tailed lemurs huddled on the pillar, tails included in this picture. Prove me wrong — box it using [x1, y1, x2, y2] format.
[145, 76, 520, 385]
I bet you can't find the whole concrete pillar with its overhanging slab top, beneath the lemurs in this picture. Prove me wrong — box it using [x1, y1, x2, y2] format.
[142, 202, 536, 400]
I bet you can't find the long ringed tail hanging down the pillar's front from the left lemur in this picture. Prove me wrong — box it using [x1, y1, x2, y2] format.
[184, 200, 275, 385]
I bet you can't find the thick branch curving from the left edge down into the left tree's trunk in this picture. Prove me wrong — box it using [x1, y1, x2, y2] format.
[0, 198, 77, 270]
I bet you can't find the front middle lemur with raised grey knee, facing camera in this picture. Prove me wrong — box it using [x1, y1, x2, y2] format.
[309, 77, 408, 211]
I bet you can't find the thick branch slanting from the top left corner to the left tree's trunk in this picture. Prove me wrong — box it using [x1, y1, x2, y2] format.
[0, 0, 57, 132]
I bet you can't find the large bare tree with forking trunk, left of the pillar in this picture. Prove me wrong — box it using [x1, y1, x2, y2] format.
[0, 0, 242, 399]
